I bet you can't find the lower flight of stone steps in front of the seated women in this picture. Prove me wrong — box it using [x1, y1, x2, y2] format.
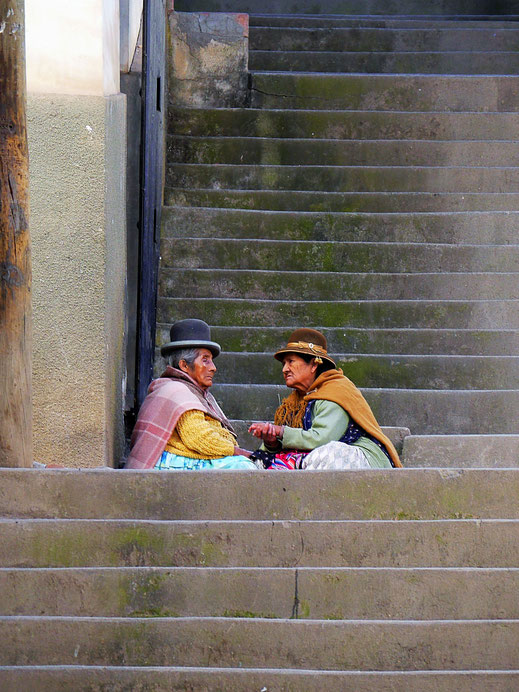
[4, 469, 519, 692]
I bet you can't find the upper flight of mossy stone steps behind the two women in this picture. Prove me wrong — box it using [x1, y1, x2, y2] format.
[157, 2, 519, 466]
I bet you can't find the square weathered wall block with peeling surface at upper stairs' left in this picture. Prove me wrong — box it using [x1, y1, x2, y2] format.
[168, 12, 249, 108]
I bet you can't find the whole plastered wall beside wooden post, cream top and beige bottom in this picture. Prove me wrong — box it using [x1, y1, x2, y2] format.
[26, 0, 126, 467]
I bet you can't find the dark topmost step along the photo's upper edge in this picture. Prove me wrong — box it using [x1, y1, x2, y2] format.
[175, 0, 519, 14]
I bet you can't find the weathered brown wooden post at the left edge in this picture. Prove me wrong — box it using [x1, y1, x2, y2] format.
[0, 0, 33, 466]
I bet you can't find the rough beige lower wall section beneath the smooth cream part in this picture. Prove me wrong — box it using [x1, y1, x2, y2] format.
[27, 94, 126, 466]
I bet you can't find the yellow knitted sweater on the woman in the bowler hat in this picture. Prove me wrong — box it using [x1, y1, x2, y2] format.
[166, 410, 236, 459]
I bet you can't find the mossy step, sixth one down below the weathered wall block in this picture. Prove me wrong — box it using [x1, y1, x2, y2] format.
[161, 239, 519, 274]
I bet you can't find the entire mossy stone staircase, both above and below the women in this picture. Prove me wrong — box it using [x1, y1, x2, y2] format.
[0, 0, 519, 692]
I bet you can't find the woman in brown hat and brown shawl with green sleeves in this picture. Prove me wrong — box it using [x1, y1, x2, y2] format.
[249, 328, 402, 469]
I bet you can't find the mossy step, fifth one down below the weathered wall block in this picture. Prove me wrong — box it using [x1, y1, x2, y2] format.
[162, 207, 519, 245]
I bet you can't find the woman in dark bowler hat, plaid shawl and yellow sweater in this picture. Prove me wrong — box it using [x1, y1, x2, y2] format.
[125, 319, 256, 471]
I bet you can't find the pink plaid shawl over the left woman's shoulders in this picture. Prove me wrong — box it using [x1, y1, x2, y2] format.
[124, 366, 234, 469]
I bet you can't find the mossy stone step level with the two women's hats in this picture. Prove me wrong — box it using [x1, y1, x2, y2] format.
[157, 323, 519, 356]
